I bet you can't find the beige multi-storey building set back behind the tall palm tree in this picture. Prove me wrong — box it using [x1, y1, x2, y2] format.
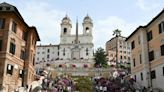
[106, 36, 131, 66]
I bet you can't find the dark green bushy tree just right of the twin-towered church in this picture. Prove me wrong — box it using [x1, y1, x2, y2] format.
[94, 47, 108, 68]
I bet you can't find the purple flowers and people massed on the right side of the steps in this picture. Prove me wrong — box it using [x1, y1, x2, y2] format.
[93, 72, 146, 92]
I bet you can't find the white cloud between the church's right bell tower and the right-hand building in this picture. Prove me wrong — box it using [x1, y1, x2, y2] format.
[93, 16, 141, 49]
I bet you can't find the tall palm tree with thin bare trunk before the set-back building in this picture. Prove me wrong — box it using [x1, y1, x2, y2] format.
[113, 29, 121, 67]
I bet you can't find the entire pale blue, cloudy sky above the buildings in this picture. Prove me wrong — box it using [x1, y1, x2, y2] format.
[0, 0, 164, 49]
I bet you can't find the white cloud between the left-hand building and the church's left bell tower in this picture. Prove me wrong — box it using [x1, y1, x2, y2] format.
[20, 2, 65, 44]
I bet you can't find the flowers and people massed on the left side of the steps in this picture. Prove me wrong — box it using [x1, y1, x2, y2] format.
[21, 68, 75, 92]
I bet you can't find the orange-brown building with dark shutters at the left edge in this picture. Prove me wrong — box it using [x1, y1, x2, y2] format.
[0, 2, 40, 92]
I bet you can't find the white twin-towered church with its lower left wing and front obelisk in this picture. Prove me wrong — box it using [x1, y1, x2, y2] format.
[35, 15, 94, 73]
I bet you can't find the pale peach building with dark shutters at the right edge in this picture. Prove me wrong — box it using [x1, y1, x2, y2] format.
[126, 10, 164, 90]
